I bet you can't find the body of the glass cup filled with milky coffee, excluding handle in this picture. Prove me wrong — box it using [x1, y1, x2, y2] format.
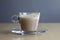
[19, 12, 40, 33]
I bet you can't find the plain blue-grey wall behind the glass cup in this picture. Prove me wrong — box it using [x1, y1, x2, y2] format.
[0, 0, 60, 23]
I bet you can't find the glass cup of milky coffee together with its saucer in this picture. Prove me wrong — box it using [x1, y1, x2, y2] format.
[11, 12, 45, 35]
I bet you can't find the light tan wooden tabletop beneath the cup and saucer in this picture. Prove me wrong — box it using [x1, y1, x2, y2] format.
[0, 23, 60, 40]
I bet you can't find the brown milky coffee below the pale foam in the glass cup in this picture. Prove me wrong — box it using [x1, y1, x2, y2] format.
[19, 17, 39, 31]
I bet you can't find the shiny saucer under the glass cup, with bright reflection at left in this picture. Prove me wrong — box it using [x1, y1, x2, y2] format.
[10, 29, 48, 35]
